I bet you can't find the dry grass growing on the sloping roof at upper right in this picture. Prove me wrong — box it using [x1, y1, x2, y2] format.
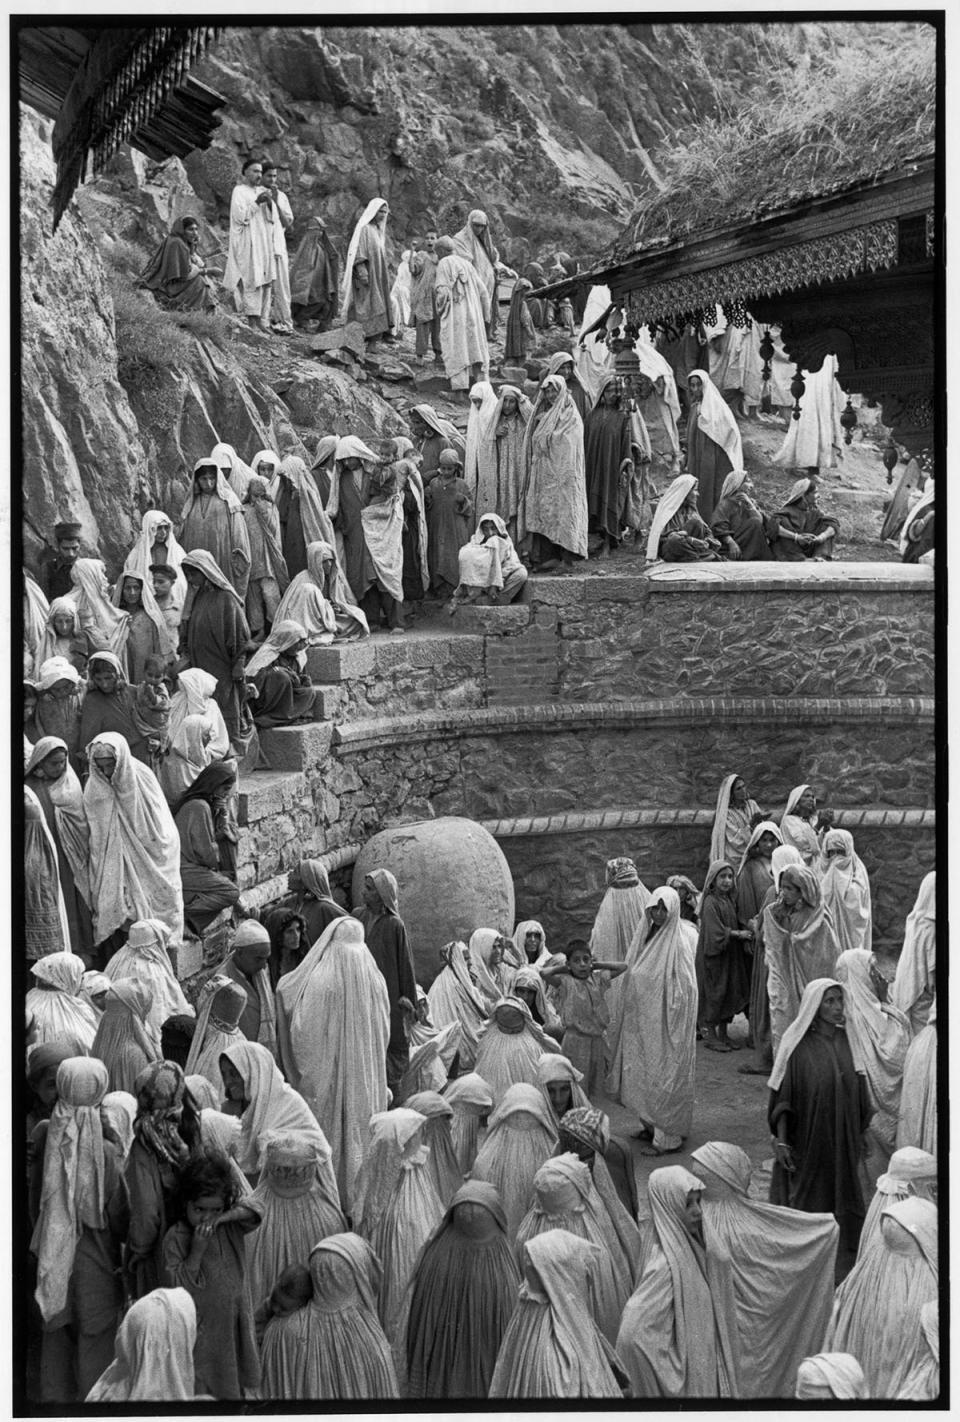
[614, 24, 936, 256]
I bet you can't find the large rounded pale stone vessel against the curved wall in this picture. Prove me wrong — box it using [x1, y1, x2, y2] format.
[353, 816, 513, 987]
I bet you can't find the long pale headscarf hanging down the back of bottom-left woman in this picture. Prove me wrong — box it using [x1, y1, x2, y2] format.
[30, 1057, 108, 1322]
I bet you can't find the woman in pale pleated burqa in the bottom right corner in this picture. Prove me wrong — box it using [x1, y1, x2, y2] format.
[823, 1199, 940, 1399]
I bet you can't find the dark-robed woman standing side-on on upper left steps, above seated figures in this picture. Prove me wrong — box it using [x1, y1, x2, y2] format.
[180, 549, 250, 757]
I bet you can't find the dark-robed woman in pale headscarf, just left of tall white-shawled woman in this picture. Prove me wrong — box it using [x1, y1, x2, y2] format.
[24, 735, 94, 956]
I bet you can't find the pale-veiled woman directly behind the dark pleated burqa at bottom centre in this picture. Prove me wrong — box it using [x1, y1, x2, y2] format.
[469, 1082, 558, 1241]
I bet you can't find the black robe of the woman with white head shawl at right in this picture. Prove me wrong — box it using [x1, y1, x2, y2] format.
[768, 1031, 872, 1278]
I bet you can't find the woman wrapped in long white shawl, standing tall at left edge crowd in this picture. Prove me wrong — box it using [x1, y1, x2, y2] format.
[84, 731, 183, 943]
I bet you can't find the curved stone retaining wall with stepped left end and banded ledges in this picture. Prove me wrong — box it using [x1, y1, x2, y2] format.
[240, 563, 936, 943]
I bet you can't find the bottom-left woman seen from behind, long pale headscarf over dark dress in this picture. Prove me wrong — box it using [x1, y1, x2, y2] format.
[30, 1057, 127, 1405]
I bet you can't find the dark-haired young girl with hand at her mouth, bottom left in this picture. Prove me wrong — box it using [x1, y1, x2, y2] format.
[164, 1155, 260, 1401]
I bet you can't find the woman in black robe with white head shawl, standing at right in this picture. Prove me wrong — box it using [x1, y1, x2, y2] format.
[767, 978, 873, 1283]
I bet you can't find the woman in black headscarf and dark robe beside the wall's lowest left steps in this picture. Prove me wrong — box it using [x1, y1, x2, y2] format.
[174, 761, 240, 936]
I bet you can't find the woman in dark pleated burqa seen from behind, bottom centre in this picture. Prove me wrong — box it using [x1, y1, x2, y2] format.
[407, 1180, 521, 1399]
